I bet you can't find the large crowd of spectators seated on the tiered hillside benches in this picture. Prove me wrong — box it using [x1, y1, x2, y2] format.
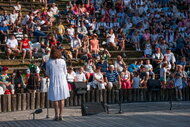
[0, 0, 190, 99]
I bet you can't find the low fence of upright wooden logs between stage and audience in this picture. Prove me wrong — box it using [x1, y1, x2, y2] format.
[0, 88, 190, 112]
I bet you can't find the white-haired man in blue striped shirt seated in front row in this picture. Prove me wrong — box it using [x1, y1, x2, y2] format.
[105, 65, 121, 90]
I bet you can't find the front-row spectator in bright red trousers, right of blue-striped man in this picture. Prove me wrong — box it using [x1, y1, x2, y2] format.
[121, 66, 131, 89]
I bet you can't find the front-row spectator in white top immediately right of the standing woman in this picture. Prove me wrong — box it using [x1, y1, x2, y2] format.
[67, 67, 76, 91]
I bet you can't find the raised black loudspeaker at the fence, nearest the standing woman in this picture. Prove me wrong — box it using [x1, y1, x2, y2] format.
[73, 82, 87, 94]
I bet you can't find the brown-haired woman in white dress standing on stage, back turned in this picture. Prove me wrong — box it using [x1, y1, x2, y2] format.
[46, 48, 70, 121]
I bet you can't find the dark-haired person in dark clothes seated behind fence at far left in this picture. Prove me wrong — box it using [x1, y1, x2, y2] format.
[12, 70, 26, 93]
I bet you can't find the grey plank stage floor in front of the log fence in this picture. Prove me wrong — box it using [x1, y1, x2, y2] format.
[0, 102, 190, 127]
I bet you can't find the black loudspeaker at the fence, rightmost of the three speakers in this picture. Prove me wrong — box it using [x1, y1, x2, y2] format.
[147, 79, 161, 91]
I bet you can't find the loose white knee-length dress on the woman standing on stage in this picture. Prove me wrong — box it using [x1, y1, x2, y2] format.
[46, 59, 70, 101]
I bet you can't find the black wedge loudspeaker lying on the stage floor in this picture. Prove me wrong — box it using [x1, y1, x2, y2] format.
[81, 102, 108, 116]
